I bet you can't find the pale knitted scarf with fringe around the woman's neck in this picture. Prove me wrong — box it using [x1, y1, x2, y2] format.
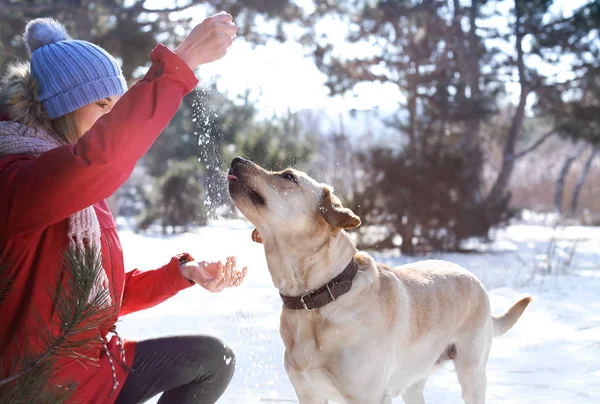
[0, 121, 112, 304]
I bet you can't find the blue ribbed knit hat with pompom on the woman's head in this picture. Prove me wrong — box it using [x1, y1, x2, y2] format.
[23, 18, 127, 119]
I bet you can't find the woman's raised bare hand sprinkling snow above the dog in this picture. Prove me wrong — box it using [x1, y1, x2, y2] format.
[175, 12, 237, 70]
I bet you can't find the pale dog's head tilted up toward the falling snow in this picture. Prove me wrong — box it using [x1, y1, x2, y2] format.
[227, 157, 360, 246]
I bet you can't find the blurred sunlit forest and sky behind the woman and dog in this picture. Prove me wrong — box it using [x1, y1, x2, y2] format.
[0, 0, 600, 254]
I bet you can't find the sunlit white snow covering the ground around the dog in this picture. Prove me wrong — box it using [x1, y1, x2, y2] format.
[119, 221, 600, 404]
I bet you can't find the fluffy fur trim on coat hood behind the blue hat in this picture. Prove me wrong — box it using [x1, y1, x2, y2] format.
[0, 62, 52, 131]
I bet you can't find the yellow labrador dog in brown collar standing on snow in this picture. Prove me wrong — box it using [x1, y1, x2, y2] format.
[228, 158, 531, 404]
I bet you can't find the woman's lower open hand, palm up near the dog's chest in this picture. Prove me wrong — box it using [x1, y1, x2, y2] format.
[181, 257, 248, 293]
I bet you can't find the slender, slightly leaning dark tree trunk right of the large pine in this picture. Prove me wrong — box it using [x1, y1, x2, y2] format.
[486, 0, 530, 205]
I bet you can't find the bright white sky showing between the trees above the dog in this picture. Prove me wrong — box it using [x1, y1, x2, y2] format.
[157, 0, 589, 114]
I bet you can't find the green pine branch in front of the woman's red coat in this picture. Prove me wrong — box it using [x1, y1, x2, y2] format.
[0, 247, 115, 404]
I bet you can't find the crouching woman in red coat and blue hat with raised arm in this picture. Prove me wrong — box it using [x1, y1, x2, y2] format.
[0, 13, 246, 403]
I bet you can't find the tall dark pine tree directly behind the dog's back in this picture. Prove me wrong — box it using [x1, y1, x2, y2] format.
[307, 0, 508, 254]
